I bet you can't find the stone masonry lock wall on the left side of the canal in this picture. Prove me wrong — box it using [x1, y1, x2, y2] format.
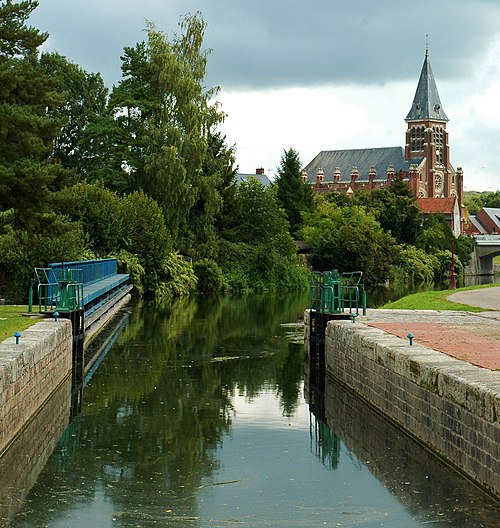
[0, 319, 72, 456]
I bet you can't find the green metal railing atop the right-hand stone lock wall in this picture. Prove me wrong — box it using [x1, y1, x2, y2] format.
[310, 270, 366, 317]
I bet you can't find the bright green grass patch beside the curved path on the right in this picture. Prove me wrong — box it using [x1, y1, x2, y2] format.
[381, 283, 500, 312]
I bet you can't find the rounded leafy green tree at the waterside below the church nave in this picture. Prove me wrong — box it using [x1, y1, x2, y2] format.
[300, 199, 398, 284]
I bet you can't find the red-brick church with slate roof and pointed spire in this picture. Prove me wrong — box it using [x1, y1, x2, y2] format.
[303, 49, 464, 235]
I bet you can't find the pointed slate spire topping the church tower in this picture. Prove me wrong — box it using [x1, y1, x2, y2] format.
[405, 45, 448, 122]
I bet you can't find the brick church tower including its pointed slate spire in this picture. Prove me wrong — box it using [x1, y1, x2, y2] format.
[405, 49, 463, 208]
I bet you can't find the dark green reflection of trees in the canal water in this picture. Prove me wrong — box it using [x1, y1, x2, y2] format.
[11, 295, 307, 527]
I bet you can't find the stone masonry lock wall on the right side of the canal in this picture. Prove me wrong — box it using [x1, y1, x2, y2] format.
[306, 313, 500, 497]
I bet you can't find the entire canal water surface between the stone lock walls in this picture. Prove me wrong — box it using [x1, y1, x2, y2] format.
[0, 295, 500, 528]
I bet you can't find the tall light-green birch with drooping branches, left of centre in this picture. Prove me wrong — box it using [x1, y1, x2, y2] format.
[140, 13, 224, 243]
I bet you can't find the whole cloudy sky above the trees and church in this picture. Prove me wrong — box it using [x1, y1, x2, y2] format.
[30, 0, 500, 190]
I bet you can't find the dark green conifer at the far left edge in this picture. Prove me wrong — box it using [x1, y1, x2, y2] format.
[0, 1, 71, 231]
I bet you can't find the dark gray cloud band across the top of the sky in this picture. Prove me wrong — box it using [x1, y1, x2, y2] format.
[31, 0, 500, 89]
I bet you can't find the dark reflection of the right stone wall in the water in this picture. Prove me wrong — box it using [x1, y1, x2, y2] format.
[307, 366, 500, 528]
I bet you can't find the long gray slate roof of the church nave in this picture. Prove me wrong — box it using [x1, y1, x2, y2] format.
[305, 147, 423, 183]
